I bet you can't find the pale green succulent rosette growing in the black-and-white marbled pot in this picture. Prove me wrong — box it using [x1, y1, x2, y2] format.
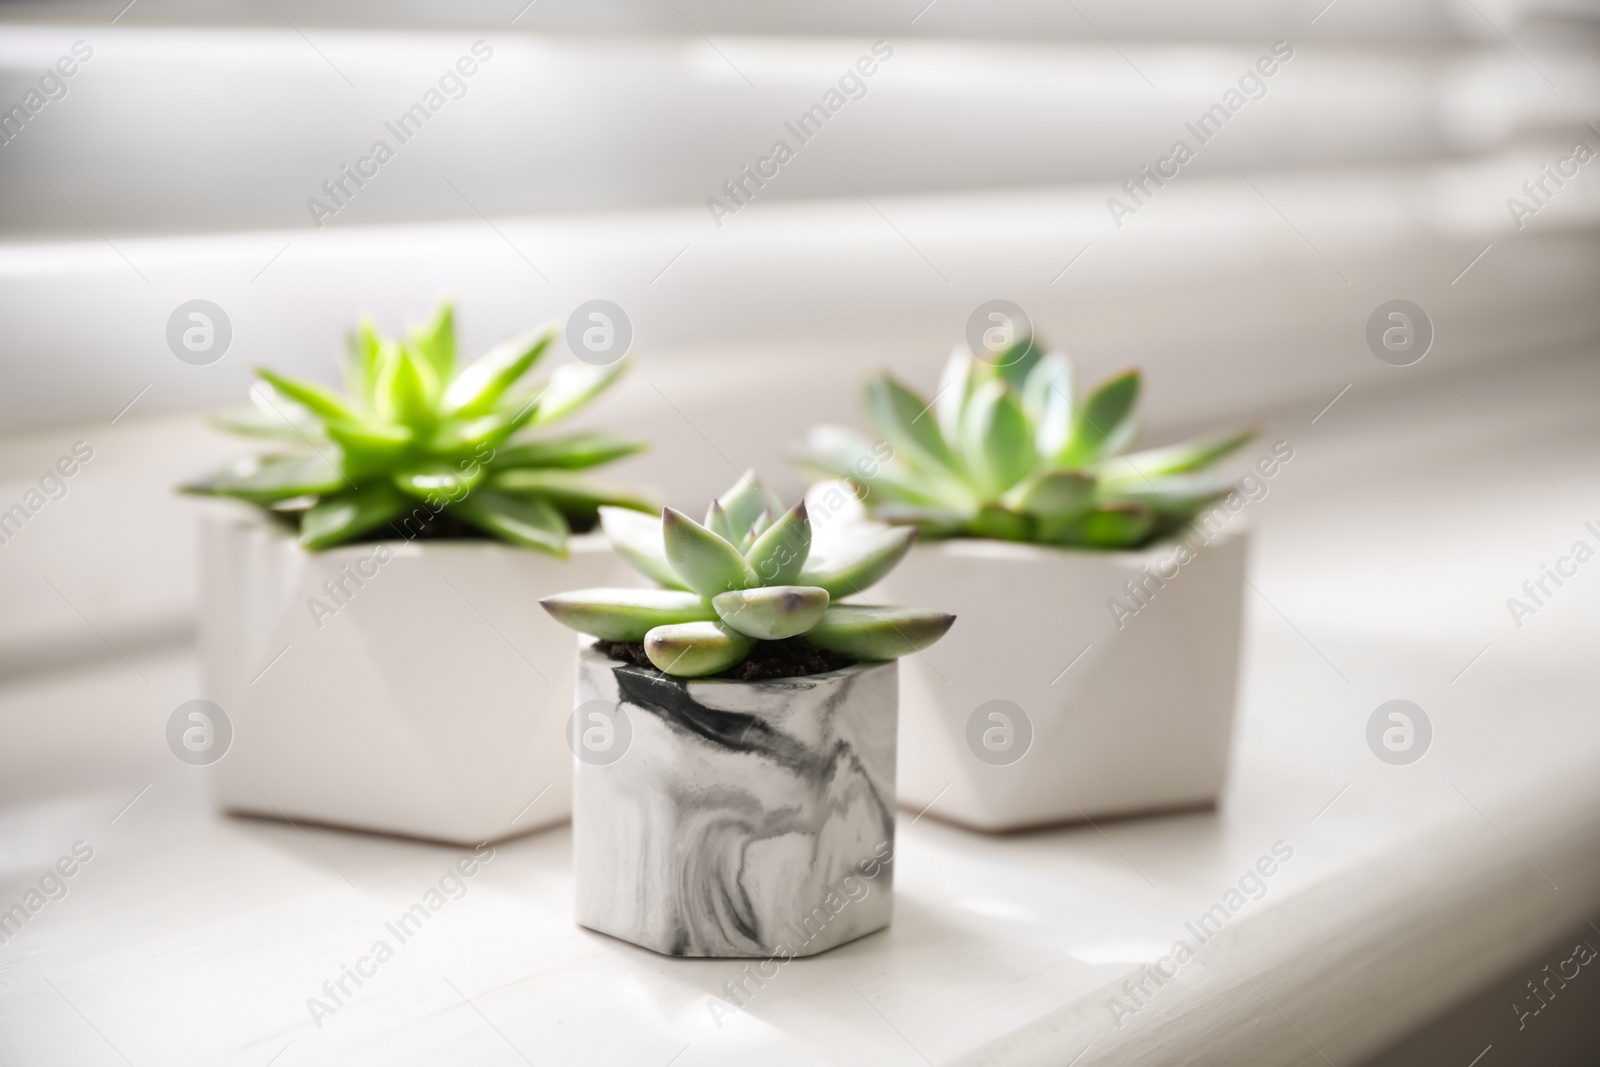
[539, 472, 955, 678]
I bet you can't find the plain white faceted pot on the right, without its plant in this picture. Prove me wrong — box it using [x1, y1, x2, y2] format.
[870, 533, 1246, 830]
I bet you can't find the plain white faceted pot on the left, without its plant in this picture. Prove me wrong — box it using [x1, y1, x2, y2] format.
[200, 506, 626, 845]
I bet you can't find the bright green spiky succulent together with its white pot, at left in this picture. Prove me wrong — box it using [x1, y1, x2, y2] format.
[184, 304, 653, 843]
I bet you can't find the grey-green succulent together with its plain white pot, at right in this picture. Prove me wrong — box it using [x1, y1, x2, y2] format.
[802, 338, 1253, 830]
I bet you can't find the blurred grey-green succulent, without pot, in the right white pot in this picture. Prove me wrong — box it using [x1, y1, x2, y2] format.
[798, 338, 1254, 549]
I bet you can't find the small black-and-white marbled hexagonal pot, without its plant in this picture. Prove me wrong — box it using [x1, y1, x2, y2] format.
[573, 648, 898, 960]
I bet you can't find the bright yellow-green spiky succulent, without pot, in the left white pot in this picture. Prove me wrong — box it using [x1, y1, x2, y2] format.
[182, 302, 654, 557]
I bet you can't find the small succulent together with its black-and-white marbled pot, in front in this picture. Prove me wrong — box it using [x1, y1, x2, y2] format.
[542, 474, 955, 960]
